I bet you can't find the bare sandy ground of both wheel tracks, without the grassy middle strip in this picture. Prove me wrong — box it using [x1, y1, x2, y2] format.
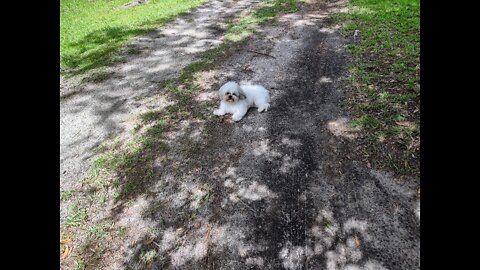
[61, 1, 420, 270]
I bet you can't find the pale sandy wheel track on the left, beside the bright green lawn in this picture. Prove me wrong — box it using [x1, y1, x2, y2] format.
[60, 0, 260, 189]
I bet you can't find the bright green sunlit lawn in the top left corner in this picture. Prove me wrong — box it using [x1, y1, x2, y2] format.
[60, 0, 206, 75]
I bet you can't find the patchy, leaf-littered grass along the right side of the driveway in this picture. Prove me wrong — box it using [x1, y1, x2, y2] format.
[336, 0, 420, 175]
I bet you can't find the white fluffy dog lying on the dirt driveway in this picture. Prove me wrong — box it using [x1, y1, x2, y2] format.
[213, 82, 270, 121]
